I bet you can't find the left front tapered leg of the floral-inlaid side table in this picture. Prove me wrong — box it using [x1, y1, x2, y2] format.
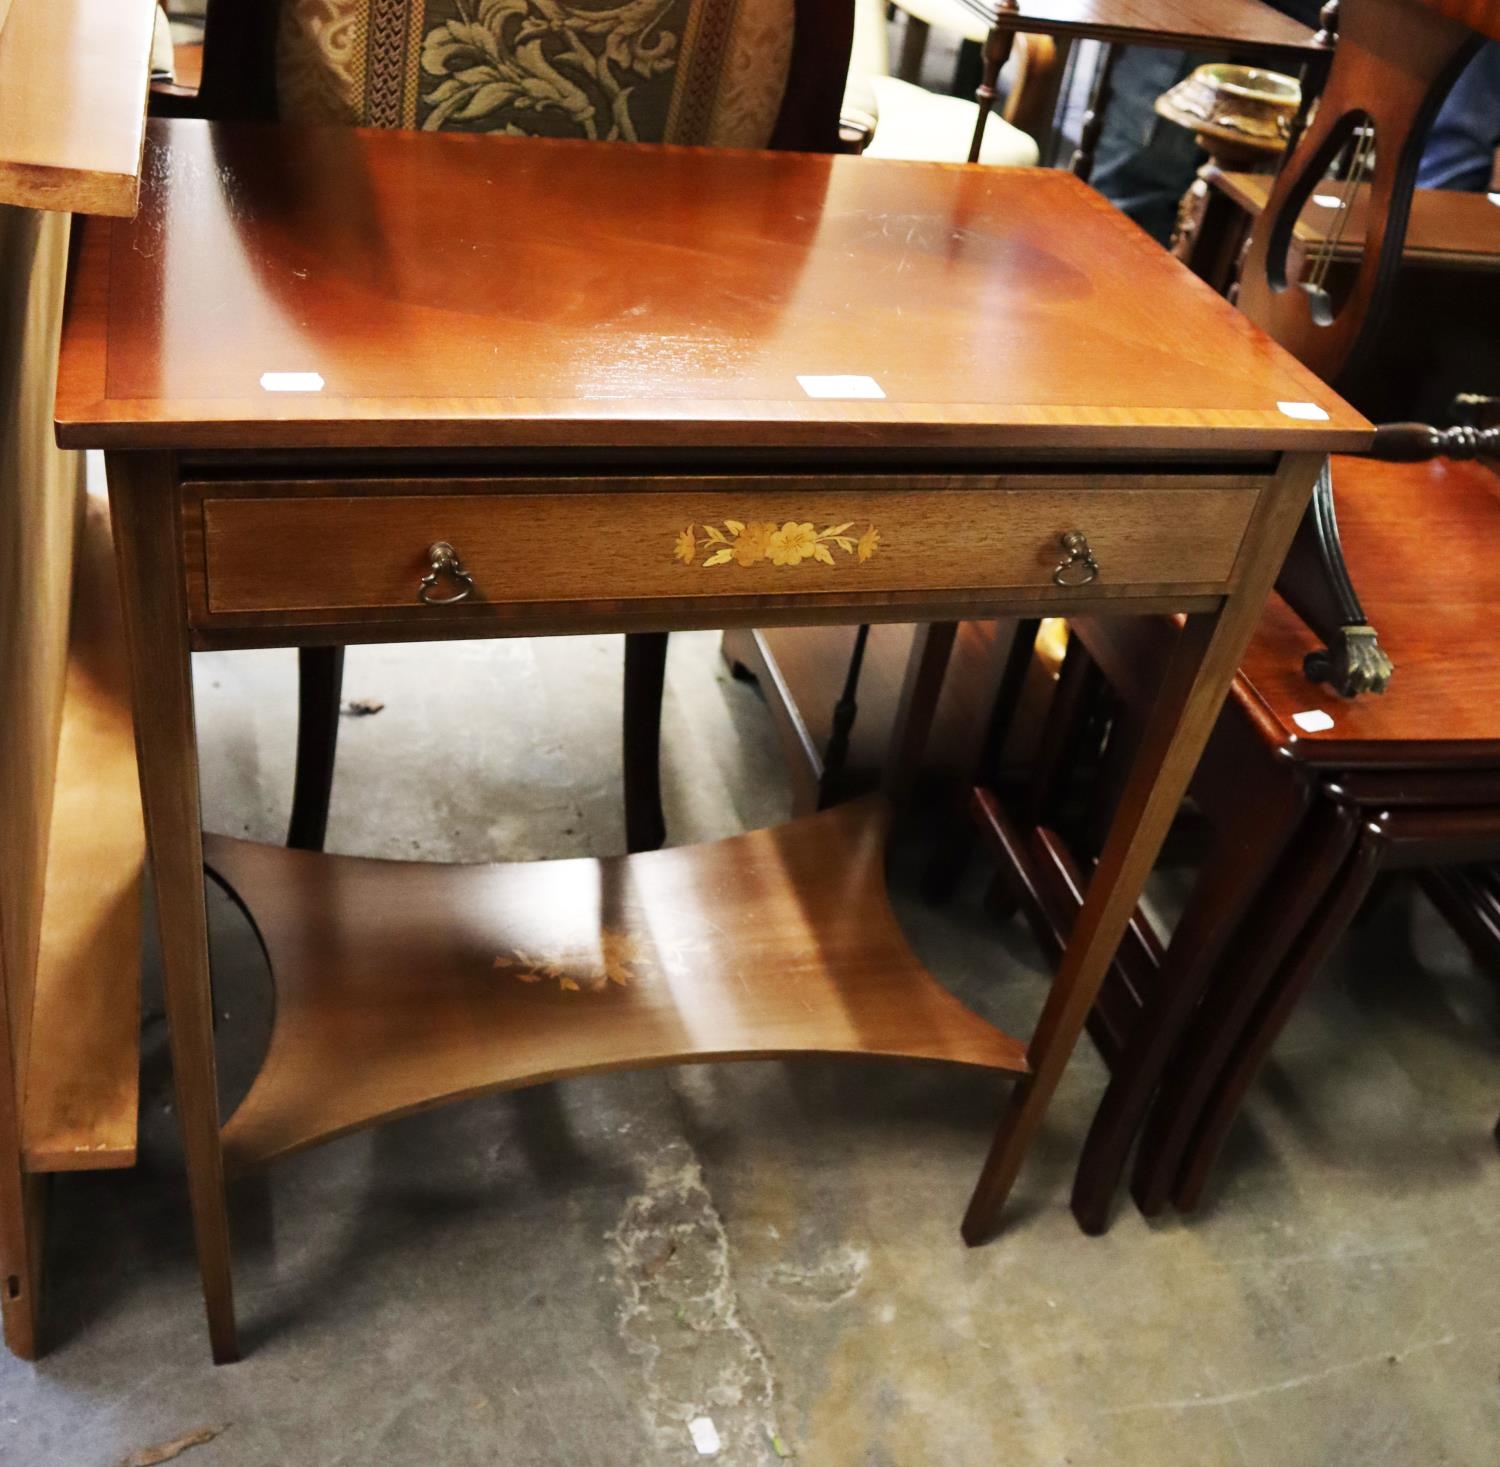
[108, 453, 240, 1365]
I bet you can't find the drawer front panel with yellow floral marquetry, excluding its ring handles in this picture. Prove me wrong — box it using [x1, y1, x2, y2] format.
[188, 479, 1259, 617]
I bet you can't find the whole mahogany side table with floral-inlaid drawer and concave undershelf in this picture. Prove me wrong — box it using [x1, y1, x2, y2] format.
[57, 122, 1370, 1361]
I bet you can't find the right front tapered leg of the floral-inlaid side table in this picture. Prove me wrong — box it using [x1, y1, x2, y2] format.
[963, 455, 1320, 1244]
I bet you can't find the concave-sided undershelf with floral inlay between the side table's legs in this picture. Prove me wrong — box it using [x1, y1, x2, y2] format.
[204, 800, 1026, 1167]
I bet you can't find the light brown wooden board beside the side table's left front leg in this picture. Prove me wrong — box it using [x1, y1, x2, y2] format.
[21, 486, 146, 1172]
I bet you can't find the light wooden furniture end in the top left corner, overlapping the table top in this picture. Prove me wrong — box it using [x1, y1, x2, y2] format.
[0, 0, 156, 215]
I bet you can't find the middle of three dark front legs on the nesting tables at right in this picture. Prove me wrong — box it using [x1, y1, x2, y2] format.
[1131, 801, 1356, 1217]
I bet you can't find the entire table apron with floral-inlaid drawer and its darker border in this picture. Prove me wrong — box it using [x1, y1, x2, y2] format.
[182, 474, 1266, 642]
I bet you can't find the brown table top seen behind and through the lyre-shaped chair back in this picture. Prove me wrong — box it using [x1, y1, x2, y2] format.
[1208, 168, 1500, 270]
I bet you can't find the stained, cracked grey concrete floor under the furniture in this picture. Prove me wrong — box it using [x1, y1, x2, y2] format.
[0, 635, 1500, 1467]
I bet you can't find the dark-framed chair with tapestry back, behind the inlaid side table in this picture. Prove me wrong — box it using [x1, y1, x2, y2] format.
[153, 0, 854, 851]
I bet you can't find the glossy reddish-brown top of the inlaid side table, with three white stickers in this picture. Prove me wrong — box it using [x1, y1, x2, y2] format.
[57, 122, 1368, 453]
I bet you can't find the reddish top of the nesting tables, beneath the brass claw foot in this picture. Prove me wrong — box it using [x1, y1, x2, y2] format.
[1241, 459, 1500, 767]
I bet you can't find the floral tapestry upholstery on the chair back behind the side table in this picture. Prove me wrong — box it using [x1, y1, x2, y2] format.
[276, 0, 794, 147]
